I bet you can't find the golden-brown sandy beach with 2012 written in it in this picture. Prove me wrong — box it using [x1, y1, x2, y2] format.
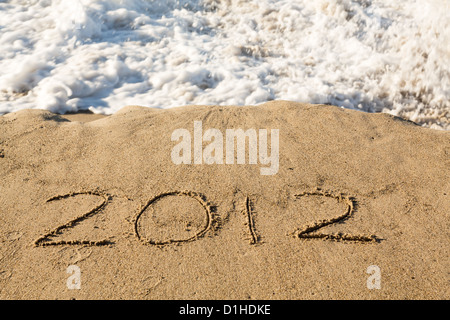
[0, 101, 450, 300]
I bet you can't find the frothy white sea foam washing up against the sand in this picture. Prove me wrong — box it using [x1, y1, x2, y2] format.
[0, 0, 450, 130]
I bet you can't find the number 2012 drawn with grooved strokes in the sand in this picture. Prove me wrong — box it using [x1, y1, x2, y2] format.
[34, 189, 379, 247]
